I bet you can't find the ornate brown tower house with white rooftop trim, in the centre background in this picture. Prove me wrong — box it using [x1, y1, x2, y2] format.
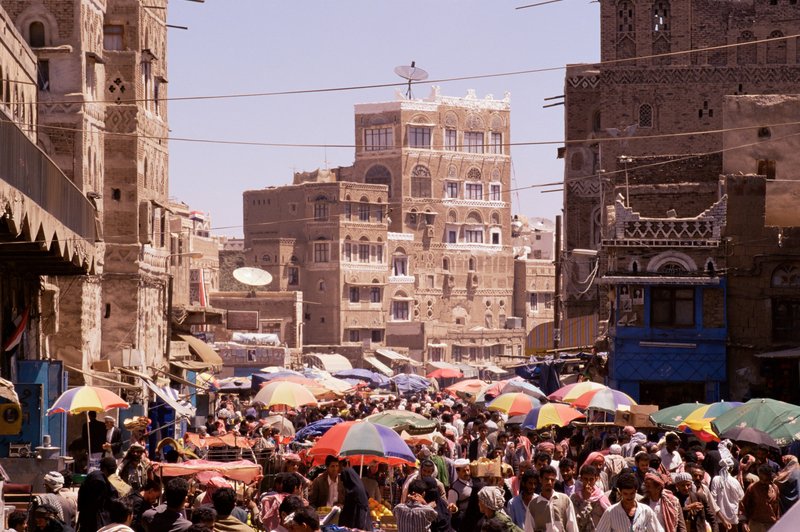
[244, 88, 524, 365]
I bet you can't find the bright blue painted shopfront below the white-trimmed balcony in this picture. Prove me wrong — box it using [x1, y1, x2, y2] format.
[609, 279, 728, 402]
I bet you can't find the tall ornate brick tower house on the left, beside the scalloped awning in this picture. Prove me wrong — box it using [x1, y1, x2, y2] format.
[0, 0, 170, 380]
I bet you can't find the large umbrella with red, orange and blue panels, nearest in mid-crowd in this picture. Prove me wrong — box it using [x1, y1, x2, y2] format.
[308, 421, 417, 465]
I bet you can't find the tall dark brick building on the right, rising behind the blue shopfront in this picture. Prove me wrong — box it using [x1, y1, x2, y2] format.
[564, 0, 800, 319]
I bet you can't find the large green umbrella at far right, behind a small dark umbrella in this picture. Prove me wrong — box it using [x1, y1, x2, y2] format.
[711, 399, 800, 447]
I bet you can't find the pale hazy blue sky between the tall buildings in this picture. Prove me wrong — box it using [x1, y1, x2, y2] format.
[168, 0, 600, 236]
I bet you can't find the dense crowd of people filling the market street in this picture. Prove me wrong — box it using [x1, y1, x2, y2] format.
[14, 386, 800, 532]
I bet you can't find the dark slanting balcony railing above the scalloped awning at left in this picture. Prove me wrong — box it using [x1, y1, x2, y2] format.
[0, 112, 95, 242]
